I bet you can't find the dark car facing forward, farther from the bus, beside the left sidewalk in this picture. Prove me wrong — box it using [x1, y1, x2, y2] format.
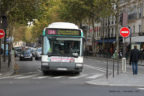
[19, 50, 33, 61]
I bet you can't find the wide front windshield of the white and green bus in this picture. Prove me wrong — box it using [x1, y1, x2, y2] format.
[43, 36, 81, 56]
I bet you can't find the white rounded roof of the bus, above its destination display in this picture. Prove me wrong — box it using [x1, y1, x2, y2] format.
[47, 22, 79, 29]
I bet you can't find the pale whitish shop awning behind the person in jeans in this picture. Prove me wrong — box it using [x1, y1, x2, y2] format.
[125, 36, 144, 43]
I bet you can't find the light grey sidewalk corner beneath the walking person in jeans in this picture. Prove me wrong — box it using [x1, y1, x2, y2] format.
[86, 57, 144, 87]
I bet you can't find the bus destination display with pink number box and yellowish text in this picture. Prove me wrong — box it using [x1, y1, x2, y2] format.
[45, 29, 81, 36]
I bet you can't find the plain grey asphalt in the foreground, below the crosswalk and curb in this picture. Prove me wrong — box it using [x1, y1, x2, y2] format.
[0, 79, 144, 96]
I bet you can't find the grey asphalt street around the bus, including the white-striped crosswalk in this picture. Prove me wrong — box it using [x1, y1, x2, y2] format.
[0, 58, 144, 96]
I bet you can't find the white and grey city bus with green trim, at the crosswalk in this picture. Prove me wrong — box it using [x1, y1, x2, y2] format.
[41, 22, 84, 74]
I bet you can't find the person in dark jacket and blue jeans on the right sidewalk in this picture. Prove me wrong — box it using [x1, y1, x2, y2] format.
[130, 46, 140, 75]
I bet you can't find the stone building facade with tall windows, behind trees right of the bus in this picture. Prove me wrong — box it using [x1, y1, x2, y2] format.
[87, 0, 144, 55]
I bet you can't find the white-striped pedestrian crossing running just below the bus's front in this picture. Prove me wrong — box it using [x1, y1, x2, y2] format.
[0, 73, 104, 80]
